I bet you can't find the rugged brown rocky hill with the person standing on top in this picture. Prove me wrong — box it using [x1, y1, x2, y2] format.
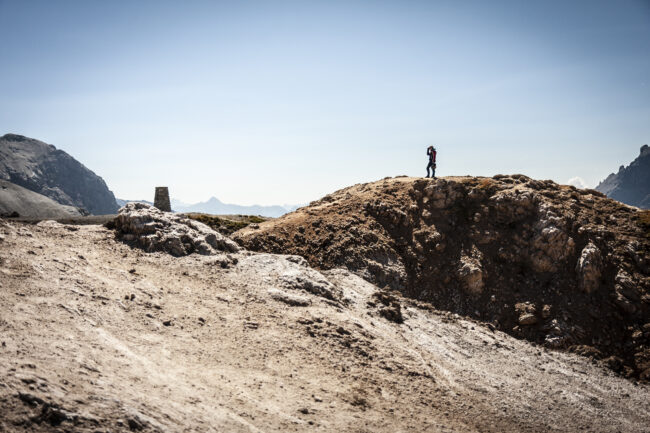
[235, 175, 650, 380]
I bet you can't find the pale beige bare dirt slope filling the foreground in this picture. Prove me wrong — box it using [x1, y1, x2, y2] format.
[0, 209, 650, 432]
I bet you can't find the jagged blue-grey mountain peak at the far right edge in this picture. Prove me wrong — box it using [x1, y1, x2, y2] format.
[596, 144, 650, 209]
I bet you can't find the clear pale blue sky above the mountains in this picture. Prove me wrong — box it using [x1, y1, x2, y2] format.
[0, 0, 650, 205]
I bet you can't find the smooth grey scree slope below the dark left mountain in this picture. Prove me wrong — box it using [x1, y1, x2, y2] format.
[0, 180, 84, 218]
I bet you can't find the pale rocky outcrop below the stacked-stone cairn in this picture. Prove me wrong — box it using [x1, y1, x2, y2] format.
[114, 202, 240, 257]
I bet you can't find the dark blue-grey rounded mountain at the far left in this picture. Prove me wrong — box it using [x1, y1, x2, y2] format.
[0, 134, 118, 215]
